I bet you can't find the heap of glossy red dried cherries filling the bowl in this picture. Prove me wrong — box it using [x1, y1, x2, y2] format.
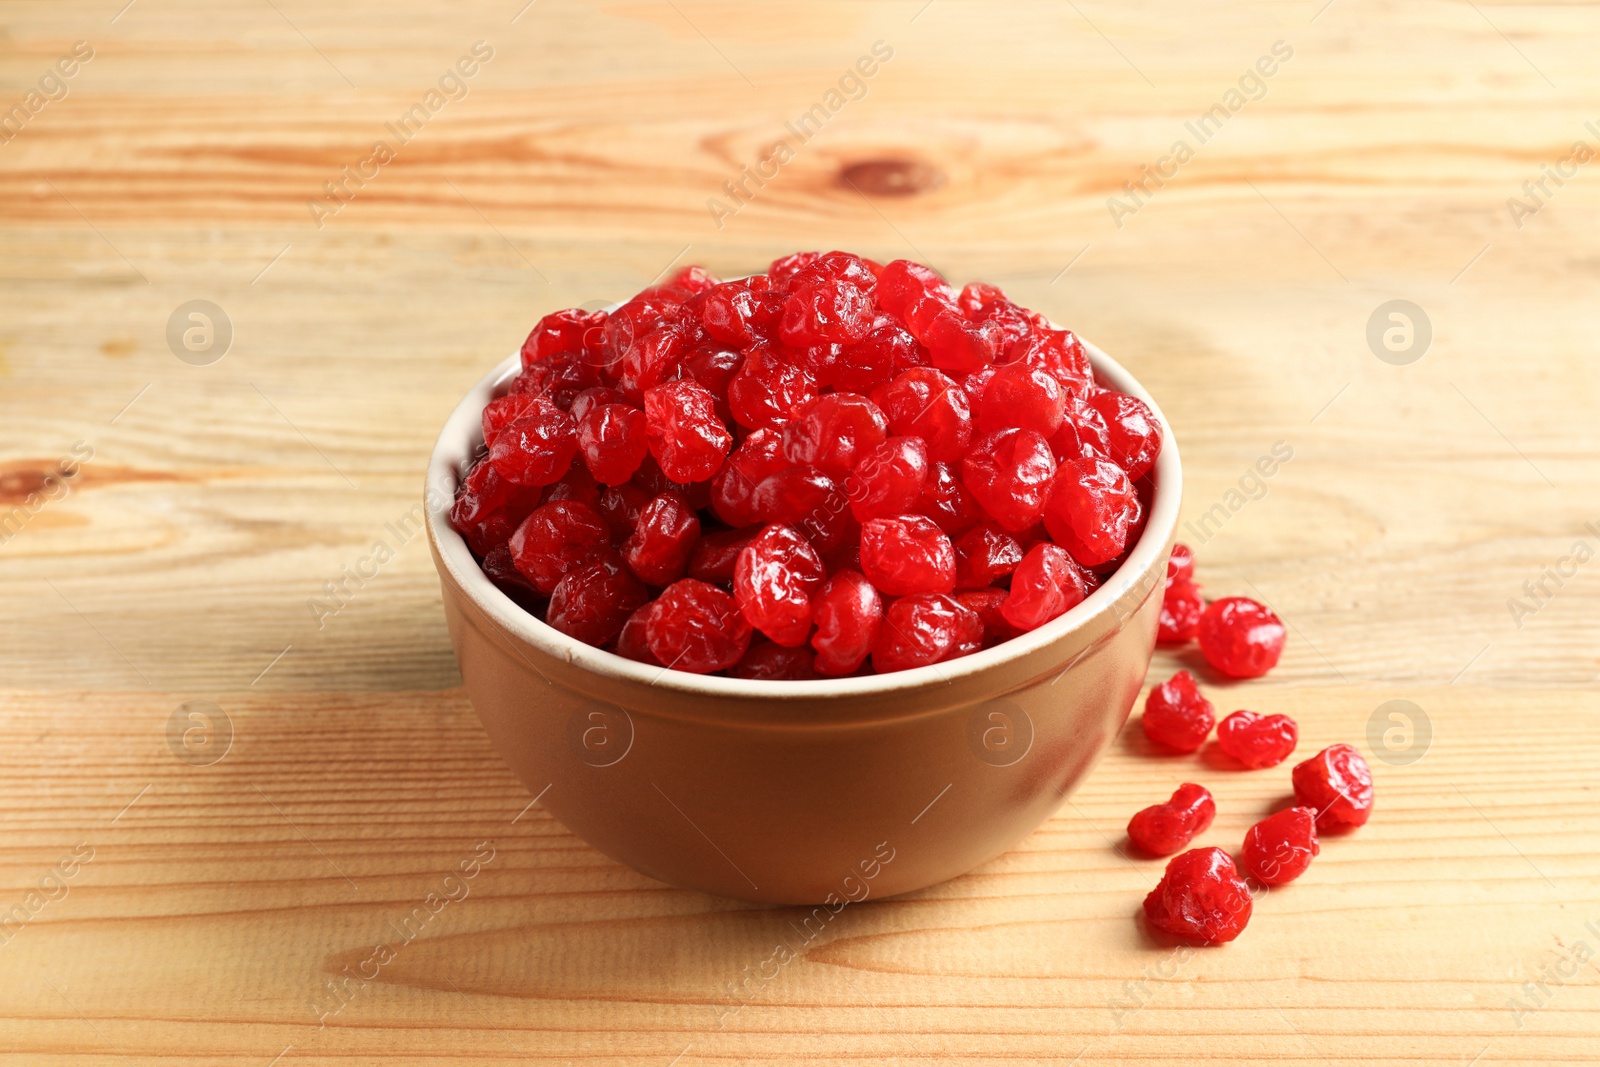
[450, 251, 1164, 675]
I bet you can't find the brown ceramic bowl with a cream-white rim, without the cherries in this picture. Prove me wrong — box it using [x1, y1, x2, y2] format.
[426, 346, 1182, 902]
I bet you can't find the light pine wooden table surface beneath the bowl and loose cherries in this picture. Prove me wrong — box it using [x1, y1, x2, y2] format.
[0, 0, 1600, 1067]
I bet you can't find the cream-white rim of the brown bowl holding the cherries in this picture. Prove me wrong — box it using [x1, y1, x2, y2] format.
[424, 338, 1182, 701]
